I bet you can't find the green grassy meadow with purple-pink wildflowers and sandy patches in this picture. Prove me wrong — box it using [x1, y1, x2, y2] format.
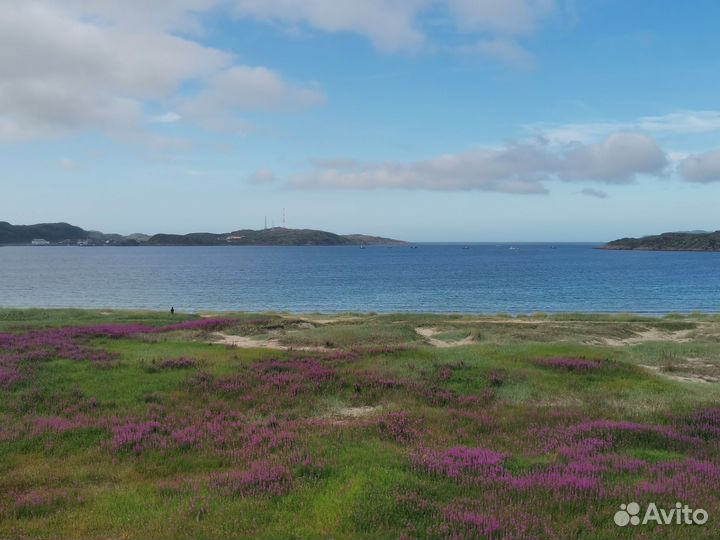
[0, 310, 720, 539]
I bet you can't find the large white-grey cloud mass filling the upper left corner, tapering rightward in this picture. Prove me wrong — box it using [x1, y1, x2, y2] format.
[0, 0, 320, 142]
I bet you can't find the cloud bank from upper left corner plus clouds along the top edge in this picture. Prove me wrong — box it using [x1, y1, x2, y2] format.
[0, 0, 568, 142]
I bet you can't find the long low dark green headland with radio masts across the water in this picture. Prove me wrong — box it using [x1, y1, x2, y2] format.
[0, 221, 405, 246]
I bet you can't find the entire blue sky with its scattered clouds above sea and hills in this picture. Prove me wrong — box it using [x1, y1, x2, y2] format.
[0, 0, 720, 241]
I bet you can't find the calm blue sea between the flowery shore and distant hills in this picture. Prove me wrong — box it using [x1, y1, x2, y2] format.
[0, 244, 720, 313]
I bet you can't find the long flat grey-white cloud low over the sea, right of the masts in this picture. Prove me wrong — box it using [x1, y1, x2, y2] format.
[291, 133, 667, 194]
